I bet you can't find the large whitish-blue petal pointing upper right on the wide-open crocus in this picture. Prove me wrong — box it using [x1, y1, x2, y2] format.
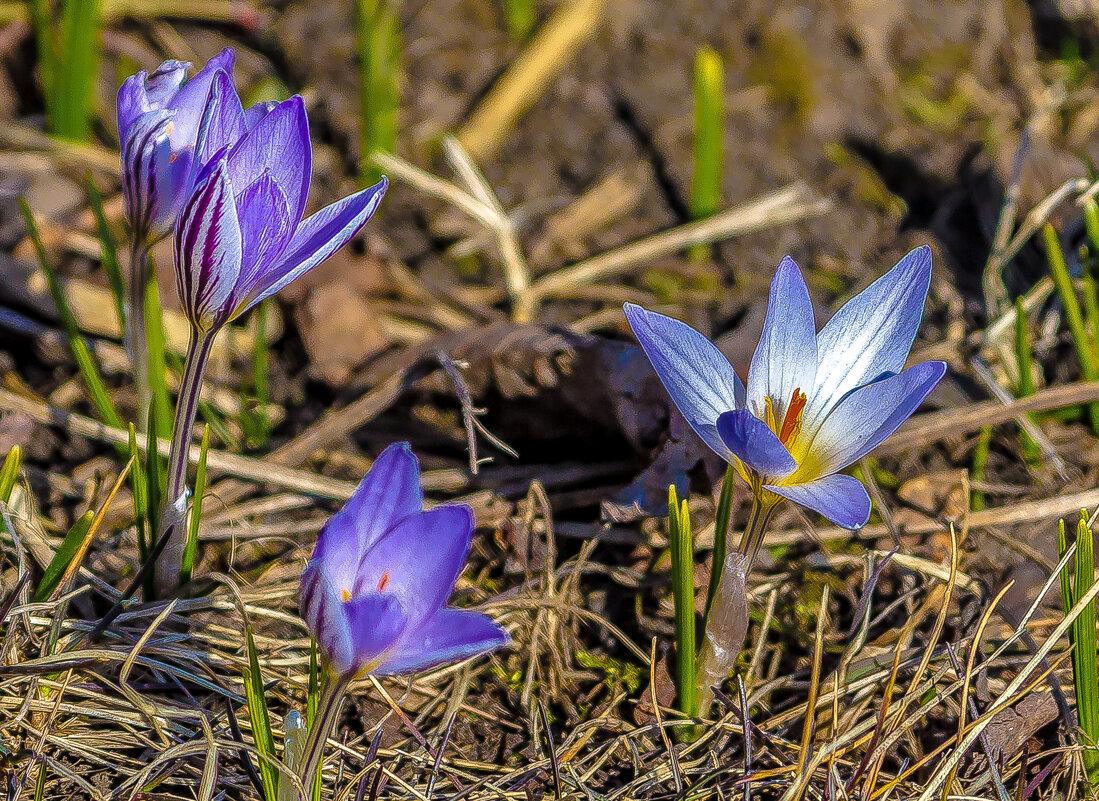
[804, 245, 931, 424]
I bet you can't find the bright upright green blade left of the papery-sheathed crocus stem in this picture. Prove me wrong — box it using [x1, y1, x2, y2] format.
[668, 485, 698, 736]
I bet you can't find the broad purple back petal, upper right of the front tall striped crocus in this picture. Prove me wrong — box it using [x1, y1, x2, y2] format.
[229, 94, 313, 222]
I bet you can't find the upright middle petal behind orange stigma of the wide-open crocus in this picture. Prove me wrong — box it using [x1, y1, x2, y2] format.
[747, 256, 817, 422]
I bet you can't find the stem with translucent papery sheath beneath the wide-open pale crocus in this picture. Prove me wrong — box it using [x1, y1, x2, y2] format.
[697, 493, 778, 715]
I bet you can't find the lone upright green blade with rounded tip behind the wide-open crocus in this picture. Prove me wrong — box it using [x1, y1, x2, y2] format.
[690, 45, 725, 262]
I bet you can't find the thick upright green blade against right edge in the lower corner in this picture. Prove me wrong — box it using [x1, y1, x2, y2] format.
[1073, 512, 1099, 788]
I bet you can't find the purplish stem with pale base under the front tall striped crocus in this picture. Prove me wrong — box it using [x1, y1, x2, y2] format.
[154, 330, 213, 593]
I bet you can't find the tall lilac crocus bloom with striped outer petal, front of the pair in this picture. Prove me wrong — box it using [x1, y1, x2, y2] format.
[176, 73, 388, 334]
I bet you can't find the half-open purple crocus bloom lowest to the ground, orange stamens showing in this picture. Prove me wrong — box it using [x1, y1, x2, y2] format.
[301, 443, 508, 680]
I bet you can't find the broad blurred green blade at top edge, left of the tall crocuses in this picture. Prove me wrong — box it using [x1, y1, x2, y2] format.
[49, 0, 99, 142]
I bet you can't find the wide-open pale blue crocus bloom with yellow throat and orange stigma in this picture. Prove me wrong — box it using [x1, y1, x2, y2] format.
[625, 246, 946, 530]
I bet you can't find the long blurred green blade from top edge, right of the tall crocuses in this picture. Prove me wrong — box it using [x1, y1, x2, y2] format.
[357, 0, 401, 186]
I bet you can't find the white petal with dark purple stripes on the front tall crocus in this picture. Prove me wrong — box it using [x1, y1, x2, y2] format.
[176, 159, 241, 331]
